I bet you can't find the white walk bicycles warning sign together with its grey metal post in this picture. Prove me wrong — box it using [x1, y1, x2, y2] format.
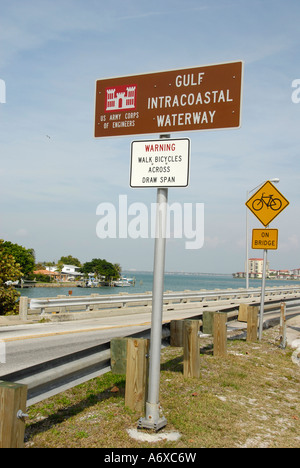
[130, 134, 190, 431]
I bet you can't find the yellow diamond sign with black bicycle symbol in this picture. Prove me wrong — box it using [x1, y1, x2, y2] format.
[246, 181, 289, 227]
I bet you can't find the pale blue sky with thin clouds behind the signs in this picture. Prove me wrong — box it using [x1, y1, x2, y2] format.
[0, 0, 300, 273]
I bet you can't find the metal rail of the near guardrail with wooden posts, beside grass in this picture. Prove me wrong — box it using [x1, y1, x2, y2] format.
[0, 297, 300, 406]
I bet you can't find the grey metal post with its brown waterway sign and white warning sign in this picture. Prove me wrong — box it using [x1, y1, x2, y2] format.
[94, 61, 243, 430]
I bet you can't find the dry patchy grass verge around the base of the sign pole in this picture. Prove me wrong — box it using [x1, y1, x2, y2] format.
[25, 329, 300, 448]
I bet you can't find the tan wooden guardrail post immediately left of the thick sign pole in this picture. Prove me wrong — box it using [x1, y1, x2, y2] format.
[125, 338, 150, 414]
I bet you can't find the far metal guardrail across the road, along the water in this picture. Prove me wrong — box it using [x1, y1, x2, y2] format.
[29, 286, 300, 313]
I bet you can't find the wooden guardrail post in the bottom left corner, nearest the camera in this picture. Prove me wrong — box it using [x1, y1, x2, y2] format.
[0, 381, 27, 448]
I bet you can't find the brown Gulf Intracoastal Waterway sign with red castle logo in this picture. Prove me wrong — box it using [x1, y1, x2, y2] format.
[95, 62, 243, 137]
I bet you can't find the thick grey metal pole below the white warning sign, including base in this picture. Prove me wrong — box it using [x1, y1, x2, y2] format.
[138, 135, 170, 431]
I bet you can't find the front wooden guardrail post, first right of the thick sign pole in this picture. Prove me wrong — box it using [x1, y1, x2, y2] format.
[183, 320, 200, 378]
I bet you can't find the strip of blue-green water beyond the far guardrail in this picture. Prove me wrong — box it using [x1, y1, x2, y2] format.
[18, 272, 298, 298]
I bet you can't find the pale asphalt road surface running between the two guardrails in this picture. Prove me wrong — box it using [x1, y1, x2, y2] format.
[0, 306, 300, 379]
